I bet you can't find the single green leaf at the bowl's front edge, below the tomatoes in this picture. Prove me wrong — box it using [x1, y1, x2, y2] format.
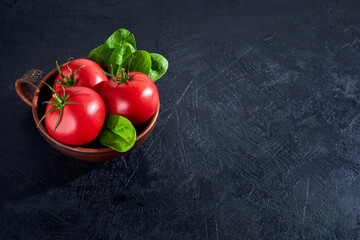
[99, 114, 136, 152]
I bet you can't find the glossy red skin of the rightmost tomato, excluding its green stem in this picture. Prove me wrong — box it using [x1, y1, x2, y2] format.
[99, 72, 159, 126]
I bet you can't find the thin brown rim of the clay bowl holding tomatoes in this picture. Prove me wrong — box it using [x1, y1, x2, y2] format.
[32, 63, 160, 154]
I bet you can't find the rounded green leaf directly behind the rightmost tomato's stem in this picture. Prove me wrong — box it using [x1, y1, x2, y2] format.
[116, 50, 151, 75]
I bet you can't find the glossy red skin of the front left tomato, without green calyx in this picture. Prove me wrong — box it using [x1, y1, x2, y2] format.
[45, 86, 106, 145]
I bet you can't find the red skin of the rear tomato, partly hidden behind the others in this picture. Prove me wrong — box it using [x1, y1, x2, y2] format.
[53, 58, 108, 92]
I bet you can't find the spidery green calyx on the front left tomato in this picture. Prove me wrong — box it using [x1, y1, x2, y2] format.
[37, 82, 82, 133]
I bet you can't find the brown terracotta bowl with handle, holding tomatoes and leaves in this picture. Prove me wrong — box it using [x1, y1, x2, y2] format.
[15, 68, 160, 161]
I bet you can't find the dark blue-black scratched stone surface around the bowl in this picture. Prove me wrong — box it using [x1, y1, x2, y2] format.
[0, 0, 360, 240]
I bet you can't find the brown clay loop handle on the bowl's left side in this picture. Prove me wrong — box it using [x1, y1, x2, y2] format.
[15, 69, 46, 107]
